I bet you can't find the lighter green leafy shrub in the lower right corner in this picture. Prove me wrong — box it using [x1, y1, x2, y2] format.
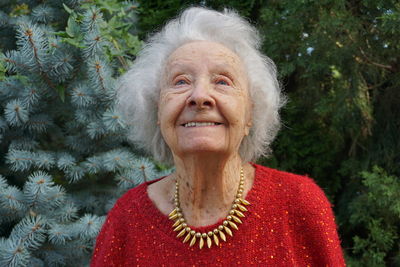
[349, 167, 400, 266]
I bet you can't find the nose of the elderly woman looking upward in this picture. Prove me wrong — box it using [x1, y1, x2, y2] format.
[186, 81, 215, 109]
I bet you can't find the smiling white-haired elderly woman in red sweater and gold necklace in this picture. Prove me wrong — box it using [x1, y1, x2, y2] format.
[91, 8, 344, 266]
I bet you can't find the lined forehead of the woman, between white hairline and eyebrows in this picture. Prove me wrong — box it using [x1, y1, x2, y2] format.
[167, 41, 243, 70]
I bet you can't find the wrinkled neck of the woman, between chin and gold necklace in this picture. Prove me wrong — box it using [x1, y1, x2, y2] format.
[175, 155, 242, 227]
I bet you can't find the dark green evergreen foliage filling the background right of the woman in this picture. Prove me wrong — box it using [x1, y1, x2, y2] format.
[260, 1, 400, 266]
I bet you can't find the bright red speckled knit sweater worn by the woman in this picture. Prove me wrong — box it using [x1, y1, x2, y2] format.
[91, 165, 345, 267]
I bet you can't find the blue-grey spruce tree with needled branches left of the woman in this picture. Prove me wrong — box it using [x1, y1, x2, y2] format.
[0, 0, 165, 266]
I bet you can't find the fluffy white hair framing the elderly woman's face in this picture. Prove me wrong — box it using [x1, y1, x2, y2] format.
[117, 7, 284, 164]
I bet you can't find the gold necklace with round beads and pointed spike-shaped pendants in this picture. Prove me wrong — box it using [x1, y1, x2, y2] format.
[168, 167, 250, 249]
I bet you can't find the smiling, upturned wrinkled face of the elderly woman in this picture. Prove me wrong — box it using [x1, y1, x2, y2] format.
[158, 41, 251, 158]
